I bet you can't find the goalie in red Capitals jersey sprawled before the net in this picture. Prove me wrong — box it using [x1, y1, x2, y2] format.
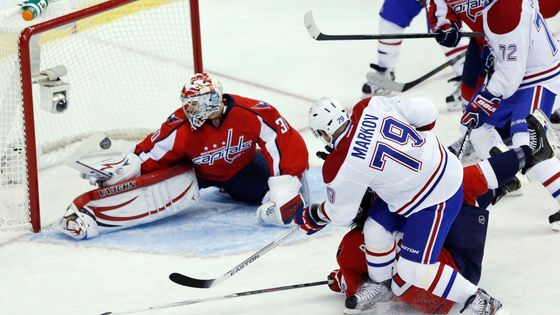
[55, 73, 308, 240]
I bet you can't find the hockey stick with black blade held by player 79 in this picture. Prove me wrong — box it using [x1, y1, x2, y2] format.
[169, 225, 299, 289]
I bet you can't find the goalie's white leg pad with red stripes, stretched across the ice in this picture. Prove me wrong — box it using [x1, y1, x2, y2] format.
[54, 165, 200, 240]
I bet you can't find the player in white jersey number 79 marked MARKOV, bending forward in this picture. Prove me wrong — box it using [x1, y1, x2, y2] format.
[295, 97, 501, 314]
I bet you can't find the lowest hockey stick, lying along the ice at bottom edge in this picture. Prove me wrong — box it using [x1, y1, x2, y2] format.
[101, 280, 329, 315]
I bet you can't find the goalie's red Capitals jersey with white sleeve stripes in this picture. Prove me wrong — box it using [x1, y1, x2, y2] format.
[134, 94, 308, 182]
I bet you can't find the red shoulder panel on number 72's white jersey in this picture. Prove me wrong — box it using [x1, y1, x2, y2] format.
[487, 0, 523, 35]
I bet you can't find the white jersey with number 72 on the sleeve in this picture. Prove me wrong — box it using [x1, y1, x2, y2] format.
[482, 0, 560, 98]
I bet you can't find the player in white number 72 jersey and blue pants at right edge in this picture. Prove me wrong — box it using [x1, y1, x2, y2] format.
[461, 0, 560, 229]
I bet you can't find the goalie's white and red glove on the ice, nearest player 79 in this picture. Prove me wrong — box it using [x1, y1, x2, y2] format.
[257, 175, 305, 226]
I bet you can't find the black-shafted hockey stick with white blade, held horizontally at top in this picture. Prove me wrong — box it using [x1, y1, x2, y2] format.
[303, 11, 484, 40]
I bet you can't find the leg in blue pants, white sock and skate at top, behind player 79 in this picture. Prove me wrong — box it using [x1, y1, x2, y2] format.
[362, 0, 422, 97]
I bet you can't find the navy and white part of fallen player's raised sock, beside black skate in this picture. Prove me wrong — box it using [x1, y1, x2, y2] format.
[479, 145, 533, 189]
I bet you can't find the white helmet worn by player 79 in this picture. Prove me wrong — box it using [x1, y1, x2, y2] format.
[309, 97, 350, 144]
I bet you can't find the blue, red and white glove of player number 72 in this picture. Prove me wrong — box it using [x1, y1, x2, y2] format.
[461, 86, 502, 128]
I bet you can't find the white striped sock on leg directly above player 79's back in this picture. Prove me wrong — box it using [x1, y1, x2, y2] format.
[377, 18, 404, 69]
